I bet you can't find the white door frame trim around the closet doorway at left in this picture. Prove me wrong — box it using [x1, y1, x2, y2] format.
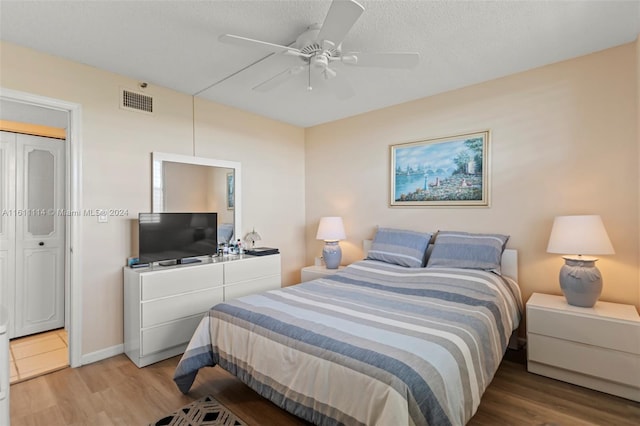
[0, 88, 82, 367]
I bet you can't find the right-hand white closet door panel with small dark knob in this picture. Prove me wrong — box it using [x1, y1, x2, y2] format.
[13, 135, 65, 337]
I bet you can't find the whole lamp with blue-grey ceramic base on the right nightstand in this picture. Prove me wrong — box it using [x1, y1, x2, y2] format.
[547, 215, 615, 308]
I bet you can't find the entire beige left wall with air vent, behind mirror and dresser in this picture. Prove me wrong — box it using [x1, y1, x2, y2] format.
[0, 42, 304, 354]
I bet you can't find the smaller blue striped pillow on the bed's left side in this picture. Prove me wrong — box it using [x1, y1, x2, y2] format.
[367, 228, 432, 268]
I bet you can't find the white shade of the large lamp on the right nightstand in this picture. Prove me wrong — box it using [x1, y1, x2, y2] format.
[547, 215, 615, 255]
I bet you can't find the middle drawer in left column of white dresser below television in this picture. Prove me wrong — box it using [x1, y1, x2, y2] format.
[142, 286, 223, 328]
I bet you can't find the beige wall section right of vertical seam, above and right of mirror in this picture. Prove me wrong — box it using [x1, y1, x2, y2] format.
[196, 99, 305, 286]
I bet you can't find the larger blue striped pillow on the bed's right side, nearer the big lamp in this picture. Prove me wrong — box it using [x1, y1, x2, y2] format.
[427, 231, 509, 275]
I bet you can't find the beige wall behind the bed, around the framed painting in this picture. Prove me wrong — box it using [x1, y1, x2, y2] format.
[305, 43, 640, 306]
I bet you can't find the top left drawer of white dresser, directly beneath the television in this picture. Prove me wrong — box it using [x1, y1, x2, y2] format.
[140, 264, 223, 300]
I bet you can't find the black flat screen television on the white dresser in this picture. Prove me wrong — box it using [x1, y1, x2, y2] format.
[138, 213, 218, 263]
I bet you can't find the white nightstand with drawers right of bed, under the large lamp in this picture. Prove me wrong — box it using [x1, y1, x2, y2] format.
[527, 293, 640, 401]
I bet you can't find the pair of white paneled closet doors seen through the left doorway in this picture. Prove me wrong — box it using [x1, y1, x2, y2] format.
[0, 132, 65, 338]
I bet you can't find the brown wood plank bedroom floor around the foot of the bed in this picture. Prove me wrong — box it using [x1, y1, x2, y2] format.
[10, 355, 640, 426]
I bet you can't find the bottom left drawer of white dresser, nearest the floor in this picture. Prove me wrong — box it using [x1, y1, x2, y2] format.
[140, 314, 204, 356]
